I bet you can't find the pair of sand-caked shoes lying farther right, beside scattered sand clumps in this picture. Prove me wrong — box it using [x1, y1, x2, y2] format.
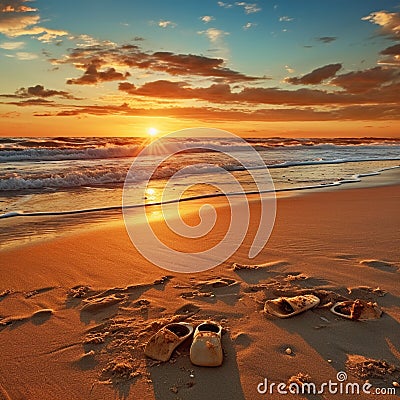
[264, 294, 382, 321]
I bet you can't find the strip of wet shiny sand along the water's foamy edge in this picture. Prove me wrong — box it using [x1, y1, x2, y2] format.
[0, 167, 400, 253]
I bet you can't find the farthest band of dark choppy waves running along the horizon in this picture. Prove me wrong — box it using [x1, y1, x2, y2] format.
[0, 137, 400, 163]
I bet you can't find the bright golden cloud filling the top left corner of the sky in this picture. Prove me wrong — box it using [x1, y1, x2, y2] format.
[0, 0, 68, 43]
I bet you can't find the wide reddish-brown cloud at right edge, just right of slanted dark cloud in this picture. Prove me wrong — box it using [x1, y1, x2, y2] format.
[331, 66, 400, 97]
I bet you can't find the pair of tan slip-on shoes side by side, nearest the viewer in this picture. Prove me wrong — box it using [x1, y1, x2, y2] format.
[144, 321, 223, 367]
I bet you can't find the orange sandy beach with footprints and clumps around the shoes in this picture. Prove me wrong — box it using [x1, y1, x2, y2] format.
[0, 176, 400, 400]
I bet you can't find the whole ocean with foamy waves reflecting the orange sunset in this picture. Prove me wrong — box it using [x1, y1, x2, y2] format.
[0, 137, 400, 249]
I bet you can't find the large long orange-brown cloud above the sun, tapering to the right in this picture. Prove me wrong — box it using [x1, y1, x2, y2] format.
[51, 44, 266, 82]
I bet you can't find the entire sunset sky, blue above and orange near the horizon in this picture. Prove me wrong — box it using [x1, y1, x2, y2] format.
[0, 0, 400, 137]
